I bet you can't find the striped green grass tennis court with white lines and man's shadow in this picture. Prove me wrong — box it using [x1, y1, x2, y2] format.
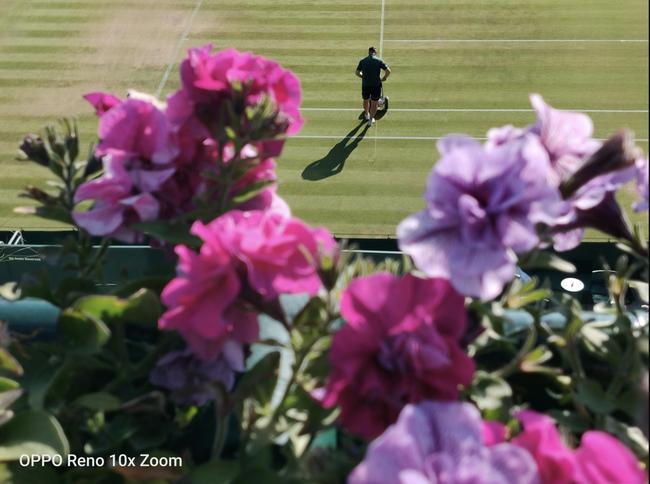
[0, 0, 648, 238]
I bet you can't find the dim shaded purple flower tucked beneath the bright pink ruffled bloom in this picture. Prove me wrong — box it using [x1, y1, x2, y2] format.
[149, 340, 244, 406]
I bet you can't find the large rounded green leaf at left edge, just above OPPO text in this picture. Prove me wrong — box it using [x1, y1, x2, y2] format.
[0, 410, 70, 461]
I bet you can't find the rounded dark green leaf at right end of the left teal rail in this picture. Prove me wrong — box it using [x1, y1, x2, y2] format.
[58, 309, 111, 353]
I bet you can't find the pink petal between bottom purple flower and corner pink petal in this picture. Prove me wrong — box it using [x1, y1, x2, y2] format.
[512, 410, 575, 484]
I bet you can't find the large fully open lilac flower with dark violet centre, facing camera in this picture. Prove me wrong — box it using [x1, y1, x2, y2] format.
[397, 135, 559, 300]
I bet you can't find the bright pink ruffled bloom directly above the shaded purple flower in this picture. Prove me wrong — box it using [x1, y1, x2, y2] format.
[159, 210, 335, 360]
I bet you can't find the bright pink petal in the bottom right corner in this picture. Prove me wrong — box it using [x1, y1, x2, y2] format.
[575, 431, 648, 484]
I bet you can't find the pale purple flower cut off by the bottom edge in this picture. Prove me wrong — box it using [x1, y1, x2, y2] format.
[348, 402, 539, 484]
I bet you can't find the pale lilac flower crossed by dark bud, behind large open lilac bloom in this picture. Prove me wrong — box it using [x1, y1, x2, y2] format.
[486, 94, 638, 251]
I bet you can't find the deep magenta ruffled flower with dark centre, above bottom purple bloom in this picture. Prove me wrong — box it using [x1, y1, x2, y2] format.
[322, 273, 474, 438]
